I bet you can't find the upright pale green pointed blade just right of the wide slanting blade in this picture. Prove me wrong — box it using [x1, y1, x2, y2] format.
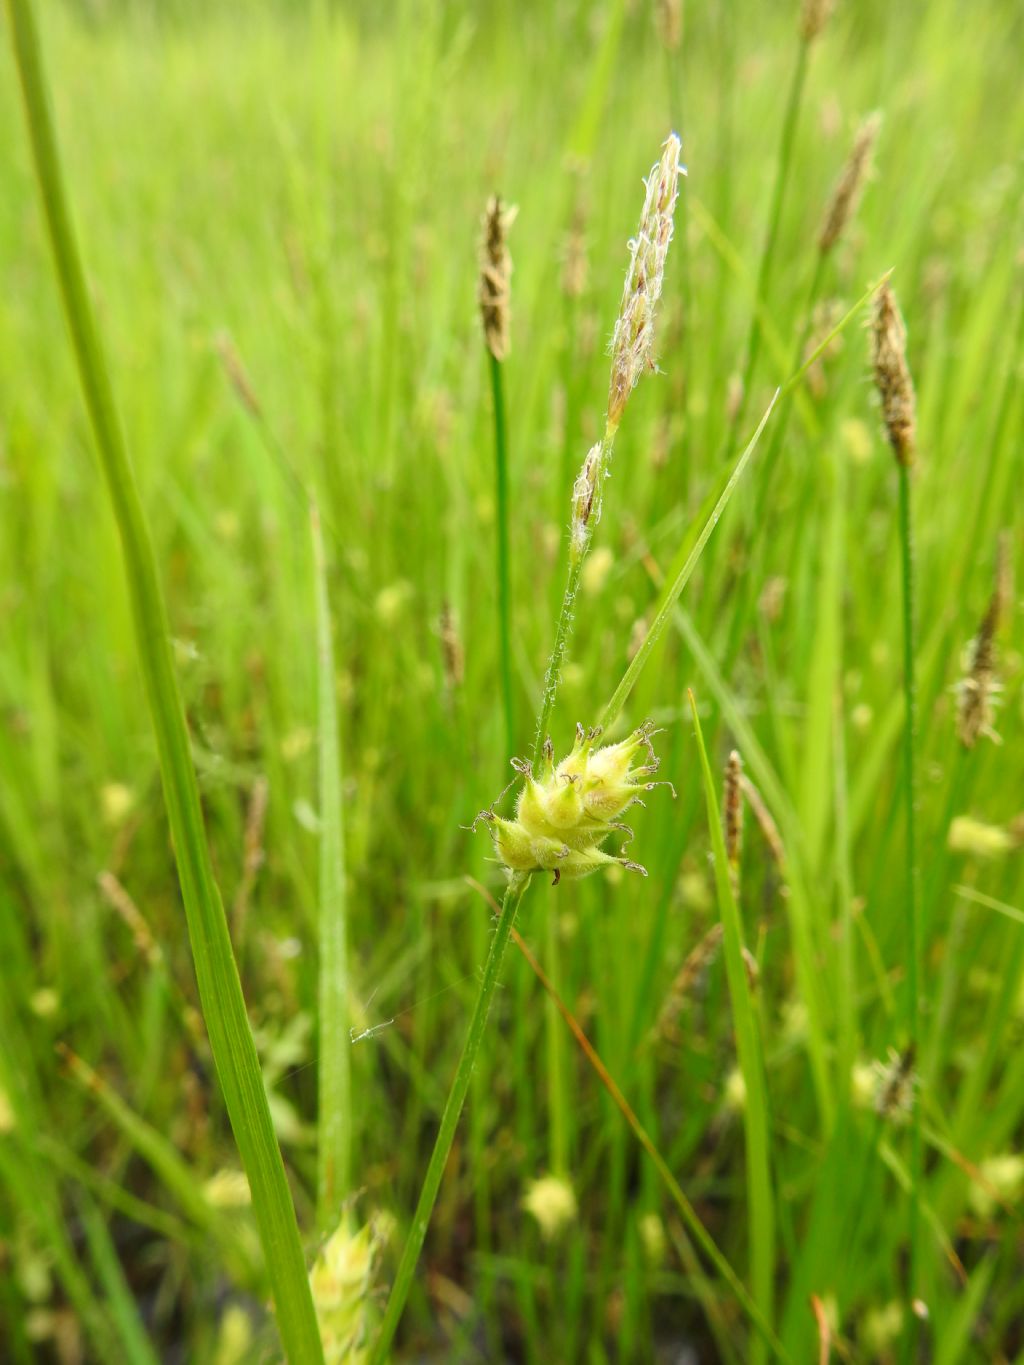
[310, 502, 352, 1233]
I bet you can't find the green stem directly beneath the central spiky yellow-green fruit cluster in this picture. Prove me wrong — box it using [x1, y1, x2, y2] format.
[370, 876, 530, 1365]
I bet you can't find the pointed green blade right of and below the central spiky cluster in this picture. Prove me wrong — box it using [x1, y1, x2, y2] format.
[689, 692, 776, 1361]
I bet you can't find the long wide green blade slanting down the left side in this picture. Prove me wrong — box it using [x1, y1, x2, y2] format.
[7, 0, 322, 1365]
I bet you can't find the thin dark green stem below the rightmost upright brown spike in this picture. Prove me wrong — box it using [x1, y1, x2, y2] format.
[898, 461, 922, 1361]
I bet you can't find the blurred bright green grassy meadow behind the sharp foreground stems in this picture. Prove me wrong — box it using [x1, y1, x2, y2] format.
[0, 0, 1024, 1365]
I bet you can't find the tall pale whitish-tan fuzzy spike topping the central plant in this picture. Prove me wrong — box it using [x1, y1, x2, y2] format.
[608, 132, 685, 430]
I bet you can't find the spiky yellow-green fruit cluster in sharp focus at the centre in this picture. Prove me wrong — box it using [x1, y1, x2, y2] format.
[481, 725, 670, 883]
